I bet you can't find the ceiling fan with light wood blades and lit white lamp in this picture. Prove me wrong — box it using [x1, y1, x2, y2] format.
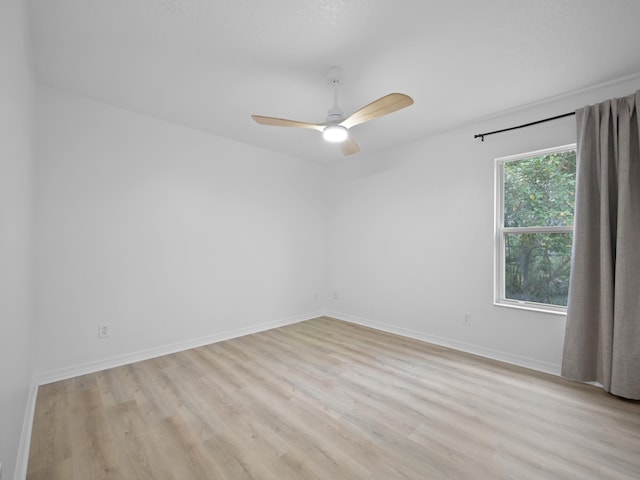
[251, 67, 413, 155]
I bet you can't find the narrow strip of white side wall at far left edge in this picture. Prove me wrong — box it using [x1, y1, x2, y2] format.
[0, 0, 33, 479]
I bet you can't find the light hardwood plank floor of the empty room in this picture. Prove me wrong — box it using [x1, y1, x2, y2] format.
[28, 318, 640, 480]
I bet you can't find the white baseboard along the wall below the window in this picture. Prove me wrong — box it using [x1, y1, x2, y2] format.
[326, 311, 561, 376]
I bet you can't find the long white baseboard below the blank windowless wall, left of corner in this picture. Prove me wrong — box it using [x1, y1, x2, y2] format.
[36, 310, 325, 385]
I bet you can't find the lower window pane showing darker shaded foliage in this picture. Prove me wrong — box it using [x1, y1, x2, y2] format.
[505, 233, 573, 306]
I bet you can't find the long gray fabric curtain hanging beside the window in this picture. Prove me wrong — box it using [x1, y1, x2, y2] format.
[562, 90, 640, 400]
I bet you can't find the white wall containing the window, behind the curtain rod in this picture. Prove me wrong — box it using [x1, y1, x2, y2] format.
[328, 77, 640, 373]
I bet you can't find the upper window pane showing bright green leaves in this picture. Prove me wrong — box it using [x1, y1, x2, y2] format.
[504, 150, 576, 231]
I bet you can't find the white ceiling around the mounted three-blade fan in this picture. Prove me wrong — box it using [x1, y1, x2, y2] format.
[28, 0, 640, 162]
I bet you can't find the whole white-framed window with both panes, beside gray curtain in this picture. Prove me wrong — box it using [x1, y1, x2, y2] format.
[495, 144, 576, 313]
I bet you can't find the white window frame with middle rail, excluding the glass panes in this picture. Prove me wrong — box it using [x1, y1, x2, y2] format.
[493, 143, 577, 315]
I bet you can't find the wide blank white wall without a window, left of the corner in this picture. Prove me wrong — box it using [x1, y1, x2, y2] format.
[35, 87, 326, 379]
